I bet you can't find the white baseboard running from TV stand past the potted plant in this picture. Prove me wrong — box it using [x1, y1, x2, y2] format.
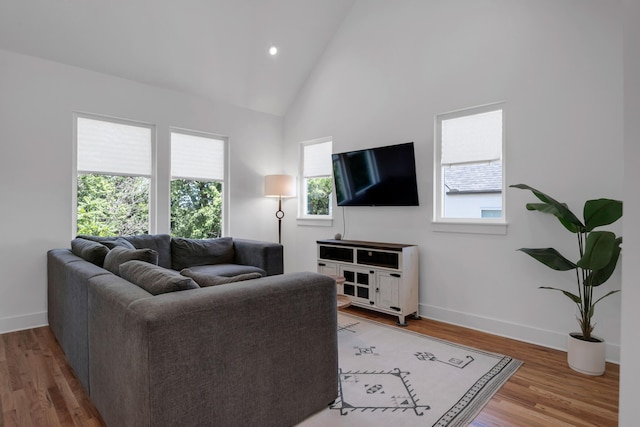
[419, 304, 620, 364]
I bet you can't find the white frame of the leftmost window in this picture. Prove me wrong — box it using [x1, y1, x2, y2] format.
[71, 112, 158, 237]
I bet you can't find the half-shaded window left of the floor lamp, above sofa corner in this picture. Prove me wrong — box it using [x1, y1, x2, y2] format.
[171, 131, 227, 239]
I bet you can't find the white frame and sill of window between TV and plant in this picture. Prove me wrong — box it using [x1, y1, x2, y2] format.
[432, 101, 507, 234]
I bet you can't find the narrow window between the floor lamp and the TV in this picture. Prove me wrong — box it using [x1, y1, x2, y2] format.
[299, 138, 333, 219]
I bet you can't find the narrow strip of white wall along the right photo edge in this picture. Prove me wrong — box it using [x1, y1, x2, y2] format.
[619, 0, 640, 427]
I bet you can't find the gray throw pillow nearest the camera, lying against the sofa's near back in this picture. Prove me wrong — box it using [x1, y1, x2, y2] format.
[120, 261, 199, 295]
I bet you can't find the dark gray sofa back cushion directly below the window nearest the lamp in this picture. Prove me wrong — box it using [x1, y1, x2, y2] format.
[171, 237, 235, 271]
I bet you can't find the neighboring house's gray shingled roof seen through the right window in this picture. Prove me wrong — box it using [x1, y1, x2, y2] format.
[444, 162, 502, 195]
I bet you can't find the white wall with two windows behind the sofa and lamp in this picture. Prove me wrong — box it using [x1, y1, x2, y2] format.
[0, 50, 283, 333]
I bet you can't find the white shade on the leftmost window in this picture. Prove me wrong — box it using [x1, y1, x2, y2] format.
[77, 117, 152, 176]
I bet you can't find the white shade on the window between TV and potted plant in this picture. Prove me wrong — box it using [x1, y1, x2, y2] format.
[442, 110, 502, 165]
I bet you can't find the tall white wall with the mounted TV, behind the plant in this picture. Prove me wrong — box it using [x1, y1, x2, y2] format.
[284, 0, 624, 361]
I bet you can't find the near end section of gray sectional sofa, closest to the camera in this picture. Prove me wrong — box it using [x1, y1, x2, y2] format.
[89, 273, 338, 426]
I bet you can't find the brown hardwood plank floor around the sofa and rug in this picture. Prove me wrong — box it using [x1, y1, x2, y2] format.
[0, 307, 620, 427]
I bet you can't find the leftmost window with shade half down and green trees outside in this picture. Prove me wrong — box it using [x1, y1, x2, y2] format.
[75, 115, 155, 236]
